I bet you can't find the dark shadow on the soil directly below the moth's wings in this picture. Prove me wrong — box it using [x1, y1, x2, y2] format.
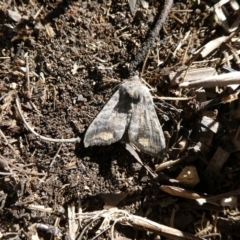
[75, 142, 153, 185]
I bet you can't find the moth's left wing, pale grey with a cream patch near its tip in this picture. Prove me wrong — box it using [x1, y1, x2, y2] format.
[84, 90, 130, 147]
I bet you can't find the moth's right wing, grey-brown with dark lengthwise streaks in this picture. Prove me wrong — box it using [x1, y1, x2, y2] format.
[128, 89, 165, 157]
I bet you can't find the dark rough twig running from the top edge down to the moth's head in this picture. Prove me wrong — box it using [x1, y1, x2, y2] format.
[130, 0, 173, 72]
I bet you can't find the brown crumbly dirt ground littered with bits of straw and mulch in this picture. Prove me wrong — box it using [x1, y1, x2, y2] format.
[0, 0, 240, 240]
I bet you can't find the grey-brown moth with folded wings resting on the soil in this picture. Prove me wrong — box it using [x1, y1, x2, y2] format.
[84, 76, 165, 157]
